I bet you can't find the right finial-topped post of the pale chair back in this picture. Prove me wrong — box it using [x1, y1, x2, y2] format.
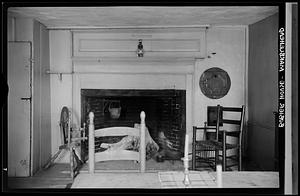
[140, 111, 146, 173]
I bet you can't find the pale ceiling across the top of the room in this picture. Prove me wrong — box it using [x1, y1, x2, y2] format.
[8, 6, 278, 29]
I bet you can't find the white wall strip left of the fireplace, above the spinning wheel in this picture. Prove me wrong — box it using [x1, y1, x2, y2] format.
[49, 31, 72, 155]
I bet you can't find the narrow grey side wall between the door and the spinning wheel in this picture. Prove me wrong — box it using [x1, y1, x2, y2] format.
[32, 21, 51, 173]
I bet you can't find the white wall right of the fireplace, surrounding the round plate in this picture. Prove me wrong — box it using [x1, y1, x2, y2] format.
[194, 27, 246, 126]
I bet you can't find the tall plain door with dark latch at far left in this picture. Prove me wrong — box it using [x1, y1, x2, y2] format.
[7, 41, 32, 177]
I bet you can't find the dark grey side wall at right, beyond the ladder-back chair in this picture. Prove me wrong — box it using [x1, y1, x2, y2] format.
[248, 14, 282, 170]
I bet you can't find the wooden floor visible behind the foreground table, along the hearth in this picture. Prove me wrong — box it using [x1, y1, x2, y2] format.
[7, 160, 259, 190]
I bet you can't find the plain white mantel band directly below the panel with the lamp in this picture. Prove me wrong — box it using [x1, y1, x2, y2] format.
[73, 57, 196, 74]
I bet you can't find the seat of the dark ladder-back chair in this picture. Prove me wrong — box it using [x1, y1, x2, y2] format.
[195, 140, 238, 151]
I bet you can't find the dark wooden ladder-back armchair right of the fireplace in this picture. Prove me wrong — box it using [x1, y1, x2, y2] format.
[192, 105, 245, 171]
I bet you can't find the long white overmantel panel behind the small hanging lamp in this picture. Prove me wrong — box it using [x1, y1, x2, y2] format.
[73, 28, 206, 58]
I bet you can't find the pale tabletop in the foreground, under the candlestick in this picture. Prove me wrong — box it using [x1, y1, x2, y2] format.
[71, 171, 279, 189]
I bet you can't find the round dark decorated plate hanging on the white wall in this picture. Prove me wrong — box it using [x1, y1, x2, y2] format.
[199, 67, 231, 99]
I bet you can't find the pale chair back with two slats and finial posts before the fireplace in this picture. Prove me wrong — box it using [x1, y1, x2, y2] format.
[88, 111, 146, 174]
